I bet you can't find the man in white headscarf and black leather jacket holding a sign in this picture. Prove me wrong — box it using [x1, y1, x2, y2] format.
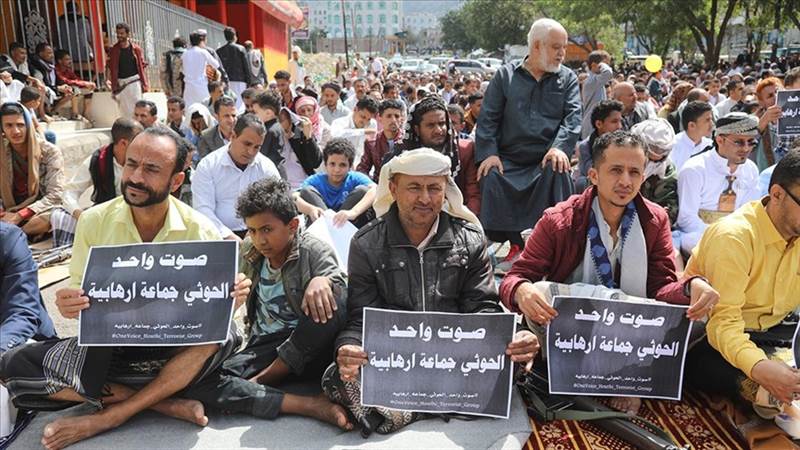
[323, 148, 539, 433]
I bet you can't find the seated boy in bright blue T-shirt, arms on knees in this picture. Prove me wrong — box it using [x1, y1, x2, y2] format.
[294, 138, 376, 228]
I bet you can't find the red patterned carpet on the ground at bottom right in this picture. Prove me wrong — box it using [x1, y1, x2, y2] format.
[525, 393, 749, 450]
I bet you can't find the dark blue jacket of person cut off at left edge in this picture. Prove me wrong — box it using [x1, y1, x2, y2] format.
[0, 222, 56, 354]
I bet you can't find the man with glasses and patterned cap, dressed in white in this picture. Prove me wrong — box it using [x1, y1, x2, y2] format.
[678, 112, 759, 254]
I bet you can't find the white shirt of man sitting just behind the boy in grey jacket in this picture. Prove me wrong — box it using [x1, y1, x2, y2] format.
[192, 145, 280, 237]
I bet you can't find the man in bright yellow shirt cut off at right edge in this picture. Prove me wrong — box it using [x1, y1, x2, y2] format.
[686, 149, 800, 428]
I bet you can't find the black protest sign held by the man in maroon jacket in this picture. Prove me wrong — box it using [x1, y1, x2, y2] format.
[547, 296, 691, 400]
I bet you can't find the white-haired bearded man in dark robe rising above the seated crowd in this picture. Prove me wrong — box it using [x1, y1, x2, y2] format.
[475, 19, 581, 261]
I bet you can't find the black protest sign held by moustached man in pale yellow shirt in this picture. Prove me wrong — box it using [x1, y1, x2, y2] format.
[78, 241, 239, 346]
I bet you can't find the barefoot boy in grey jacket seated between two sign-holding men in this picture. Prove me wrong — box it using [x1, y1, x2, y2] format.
[191, 178, 352, 430]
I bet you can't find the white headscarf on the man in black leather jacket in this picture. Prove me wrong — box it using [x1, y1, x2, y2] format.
[372, 147, 481, 227]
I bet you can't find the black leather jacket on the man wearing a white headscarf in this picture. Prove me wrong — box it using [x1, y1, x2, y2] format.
[334, 204, 502, 351]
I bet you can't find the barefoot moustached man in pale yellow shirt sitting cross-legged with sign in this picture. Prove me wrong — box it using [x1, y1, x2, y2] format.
[0, 127, 250, 450]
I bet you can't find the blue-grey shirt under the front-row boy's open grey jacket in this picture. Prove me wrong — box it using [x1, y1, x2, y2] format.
[256, 258, 299, 336]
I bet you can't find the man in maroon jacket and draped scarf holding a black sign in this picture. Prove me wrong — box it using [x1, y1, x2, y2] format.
[500, 131, 718, 412]
